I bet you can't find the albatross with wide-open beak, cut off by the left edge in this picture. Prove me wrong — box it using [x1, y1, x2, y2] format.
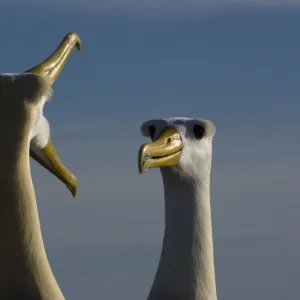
[0, 33, 81, 300]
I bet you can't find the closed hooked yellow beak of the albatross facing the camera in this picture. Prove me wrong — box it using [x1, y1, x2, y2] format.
[138, 127, 183, 173]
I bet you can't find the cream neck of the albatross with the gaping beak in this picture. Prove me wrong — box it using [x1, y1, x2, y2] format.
[0, 133, 64, 300]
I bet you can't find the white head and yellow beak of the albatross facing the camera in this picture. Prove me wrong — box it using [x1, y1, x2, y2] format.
[138, 118, 215, 178]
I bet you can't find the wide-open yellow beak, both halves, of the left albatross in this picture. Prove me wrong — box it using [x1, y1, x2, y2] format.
[25, 32, 81, 197]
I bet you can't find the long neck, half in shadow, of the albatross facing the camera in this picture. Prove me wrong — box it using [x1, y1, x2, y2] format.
[148, 168, 217, 300]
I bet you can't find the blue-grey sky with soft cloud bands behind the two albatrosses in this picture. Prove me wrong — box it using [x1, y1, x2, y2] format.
[0, 0, 300, 300]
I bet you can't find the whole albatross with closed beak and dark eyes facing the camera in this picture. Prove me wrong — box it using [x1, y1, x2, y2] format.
[138, 118, 217, 300]
